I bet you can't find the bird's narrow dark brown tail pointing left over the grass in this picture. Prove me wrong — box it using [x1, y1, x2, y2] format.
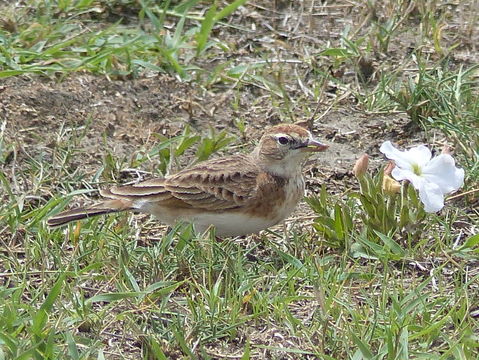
[47, 199, 132, 227]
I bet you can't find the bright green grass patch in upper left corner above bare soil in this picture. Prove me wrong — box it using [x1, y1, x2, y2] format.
[0, 0, 251, 78]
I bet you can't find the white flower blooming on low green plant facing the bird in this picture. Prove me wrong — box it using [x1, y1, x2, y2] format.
[379, 141, 464, 212]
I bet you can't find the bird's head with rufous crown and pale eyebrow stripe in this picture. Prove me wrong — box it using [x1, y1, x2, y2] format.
[254, 124, 328, 176]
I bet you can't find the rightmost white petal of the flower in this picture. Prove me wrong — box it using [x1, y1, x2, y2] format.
[422, 154, 464, 194]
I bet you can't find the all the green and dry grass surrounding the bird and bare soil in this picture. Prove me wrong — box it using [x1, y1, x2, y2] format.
[0, 0, 479, 360]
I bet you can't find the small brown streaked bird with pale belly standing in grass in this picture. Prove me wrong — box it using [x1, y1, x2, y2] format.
[47, 124, 329, 238]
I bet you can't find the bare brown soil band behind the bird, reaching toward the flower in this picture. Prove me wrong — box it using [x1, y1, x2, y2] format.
[0, 74, 407, 187]
